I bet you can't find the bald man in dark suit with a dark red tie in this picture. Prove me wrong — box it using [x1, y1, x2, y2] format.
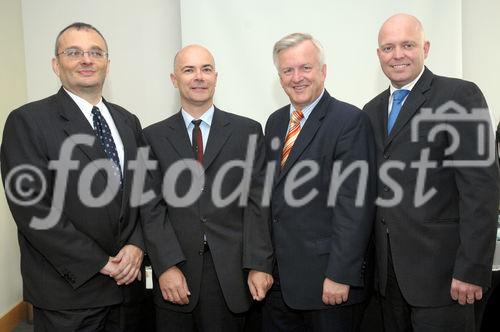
[144, 45, 273, 331]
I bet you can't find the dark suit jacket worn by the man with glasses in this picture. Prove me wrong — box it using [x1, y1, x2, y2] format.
[1, 88, 144, 310]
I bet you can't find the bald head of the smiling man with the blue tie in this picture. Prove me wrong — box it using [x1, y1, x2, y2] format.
[377, 14, 430, 88]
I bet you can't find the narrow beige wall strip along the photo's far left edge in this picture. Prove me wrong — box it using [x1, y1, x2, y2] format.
[0, 0, 26, 317]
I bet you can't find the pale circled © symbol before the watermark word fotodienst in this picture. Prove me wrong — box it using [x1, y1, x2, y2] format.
[5, 165, 47, 206]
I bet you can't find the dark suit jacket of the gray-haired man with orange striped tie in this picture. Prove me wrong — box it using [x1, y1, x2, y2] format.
[266, 91, 375, 310]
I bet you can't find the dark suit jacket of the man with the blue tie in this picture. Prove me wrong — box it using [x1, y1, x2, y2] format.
[364, 68, 499, 306]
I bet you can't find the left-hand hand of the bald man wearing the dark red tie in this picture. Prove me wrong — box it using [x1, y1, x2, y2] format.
[158, 266, 191, 304]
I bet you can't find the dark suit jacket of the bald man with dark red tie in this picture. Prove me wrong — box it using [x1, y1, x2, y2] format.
[143, 108, 272, 313]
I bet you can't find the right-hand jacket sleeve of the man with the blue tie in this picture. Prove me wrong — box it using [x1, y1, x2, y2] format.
[450, 82, 500, 286]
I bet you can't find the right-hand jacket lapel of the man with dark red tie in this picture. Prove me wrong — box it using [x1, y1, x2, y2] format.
[203, 108, 232, 169]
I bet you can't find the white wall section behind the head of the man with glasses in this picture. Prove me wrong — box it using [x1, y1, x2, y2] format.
[22, 0, 180, 126]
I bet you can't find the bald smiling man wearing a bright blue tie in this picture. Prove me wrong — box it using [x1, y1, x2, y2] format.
[364, 14, 499, 331]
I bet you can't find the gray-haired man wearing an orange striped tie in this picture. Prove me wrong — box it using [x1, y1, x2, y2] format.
[263, 33, 374, 331]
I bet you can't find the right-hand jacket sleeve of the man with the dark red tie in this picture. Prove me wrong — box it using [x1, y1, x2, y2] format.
[243, 125, 273, 273]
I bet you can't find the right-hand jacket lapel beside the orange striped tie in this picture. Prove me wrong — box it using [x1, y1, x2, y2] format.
[276, 90, 331, 184]
